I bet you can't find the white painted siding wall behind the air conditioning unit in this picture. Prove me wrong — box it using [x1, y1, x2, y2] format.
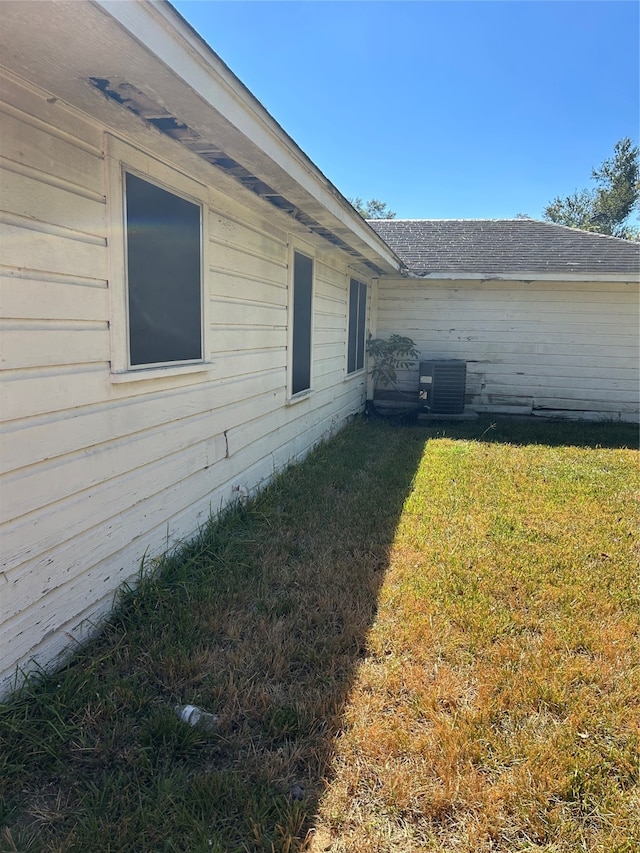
[377, 279, 640, 421]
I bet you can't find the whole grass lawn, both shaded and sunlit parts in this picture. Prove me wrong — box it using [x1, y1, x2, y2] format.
[0, 420, 640, 853]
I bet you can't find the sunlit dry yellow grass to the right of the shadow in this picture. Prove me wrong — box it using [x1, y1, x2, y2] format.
[308, 438, 640, 853]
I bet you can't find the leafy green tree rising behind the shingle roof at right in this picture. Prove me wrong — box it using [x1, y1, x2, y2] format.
[542, 137, 640, 240]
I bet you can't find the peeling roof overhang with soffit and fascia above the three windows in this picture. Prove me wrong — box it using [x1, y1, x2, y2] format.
[0, 0, 403, 275]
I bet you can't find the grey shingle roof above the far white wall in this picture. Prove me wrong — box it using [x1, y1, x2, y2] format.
[369, 219, 640, 276]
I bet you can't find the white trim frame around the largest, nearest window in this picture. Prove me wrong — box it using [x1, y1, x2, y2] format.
[105, 134, 212, 384]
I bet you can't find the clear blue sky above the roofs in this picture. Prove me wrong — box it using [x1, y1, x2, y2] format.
[173, 0, 640, 218]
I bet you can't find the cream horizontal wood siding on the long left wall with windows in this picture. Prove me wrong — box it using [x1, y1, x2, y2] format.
[0, 68, 365, 692]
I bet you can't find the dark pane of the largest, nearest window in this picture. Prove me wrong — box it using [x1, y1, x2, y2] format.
[125, 173, 203, 367]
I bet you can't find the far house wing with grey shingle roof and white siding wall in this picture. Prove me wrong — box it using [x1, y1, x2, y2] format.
[370, 219, 640, 421]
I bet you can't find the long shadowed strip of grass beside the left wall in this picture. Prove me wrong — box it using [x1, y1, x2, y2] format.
[0, 422, 428, 853]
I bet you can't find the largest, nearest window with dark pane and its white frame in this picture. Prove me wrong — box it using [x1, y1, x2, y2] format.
[104, 133, 211, 383]
